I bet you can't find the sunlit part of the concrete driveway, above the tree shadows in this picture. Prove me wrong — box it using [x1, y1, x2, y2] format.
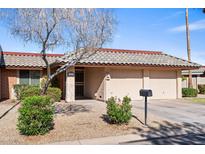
[133, 99, 205, 124]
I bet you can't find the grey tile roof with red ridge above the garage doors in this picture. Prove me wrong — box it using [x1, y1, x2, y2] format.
[57, 48, 200, 68]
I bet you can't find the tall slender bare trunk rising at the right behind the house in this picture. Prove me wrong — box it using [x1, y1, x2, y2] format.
[186, 8, 193, 88]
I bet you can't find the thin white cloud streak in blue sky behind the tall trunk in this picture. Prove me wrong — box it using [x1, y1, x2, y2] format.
[169, 19, 205, 32]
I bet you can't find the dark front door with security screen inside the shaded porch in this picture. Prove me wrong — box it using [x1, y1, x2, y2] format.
[75, 68, 84, 99]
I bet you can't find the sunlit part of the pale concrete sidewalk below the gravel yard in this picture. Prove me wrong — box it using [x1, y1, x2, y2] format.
[51, 134, 145, 145]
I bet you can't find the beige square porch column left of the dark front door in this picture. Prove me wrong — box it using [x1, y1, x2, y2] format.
[65, 67, 75, 102]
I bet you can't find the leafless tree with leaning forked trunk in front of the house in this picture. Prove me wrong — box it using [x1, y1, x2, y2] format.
[5, 9, 116, 94]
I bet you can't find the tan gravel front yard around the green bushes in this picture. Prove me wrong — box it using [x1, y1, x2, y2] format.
[0, 100, 176, 144]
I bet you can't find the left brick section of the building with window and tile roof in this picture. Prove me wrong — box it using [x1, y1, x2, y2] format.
[0, 52, 64, 99]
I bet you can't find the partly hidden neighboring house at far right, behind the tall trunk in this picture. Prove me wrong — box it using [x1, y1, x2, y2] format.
[182, 66, 205, 89]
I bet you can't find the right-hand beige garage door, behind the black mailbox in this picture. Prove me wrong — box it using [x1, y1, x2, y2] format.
[150, 71, 176, 99]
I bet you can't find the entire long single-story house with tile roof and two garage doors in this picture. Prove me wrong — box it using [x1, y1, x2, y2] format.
[0, 49, 200, 102]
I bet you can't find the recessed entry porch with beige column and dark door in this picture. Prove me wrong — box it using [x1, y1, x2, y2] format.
[65, 67, 106, 102]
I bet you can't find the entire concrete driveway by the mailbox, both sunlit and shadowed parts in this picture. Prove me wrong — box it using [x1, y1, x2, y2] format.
[126, 99, 205, 144]
